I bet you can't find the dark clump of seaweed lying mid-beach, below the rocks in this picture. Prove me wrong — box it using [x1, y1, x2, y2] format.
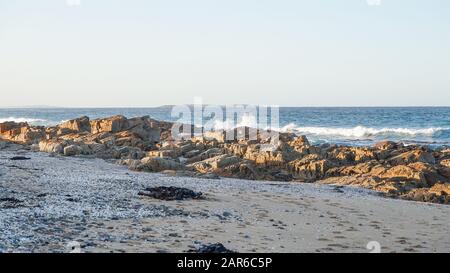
[138, 187, 203, 201]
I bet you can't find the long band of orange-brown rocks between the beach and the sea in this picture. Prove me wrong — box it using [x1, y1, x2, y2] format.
[0, 116, 450, 203]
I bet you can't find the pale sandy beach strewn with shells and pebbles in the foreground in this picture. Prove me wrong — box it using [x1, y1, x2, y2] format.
[0, 144, 450, 253]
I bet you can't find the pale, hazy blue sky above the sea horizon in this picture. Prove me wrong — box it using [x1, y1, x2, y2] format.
[0, 0, 450, 107]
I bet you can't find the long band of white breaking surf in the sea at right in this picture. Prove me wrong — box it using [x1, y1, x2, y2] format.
[281, 124, 449, 138]
